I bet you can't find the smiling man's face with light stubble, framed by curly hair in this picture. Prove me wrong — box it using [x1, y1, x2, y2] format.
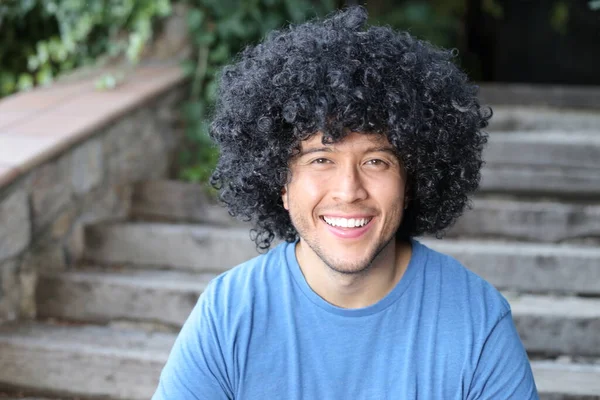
[282, 133, 406, 274]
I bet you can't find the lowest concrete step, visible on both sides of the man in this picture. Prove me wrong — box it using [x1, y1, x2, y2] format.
[0, 323, 600, 400]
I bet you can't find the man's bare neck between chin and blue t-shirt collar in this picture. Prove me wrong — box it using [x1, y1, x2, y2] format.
[296, 241, 412, 309]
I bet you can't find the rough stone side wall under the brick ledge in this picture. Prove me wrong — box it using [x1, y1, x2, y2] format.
[0, 66, 185, 322]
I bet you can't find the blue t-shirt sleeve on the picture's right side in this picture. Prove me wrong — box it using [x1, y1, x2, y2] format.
[467, 311, 539, 400]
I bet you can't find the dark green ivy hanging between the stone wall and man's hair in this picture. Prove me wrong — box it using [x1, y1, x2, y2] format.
[180, 0, 337, 182]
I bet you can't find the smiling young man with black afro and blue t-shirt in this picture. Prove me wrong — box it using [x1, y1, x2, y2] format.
[154, 8, 538, 400]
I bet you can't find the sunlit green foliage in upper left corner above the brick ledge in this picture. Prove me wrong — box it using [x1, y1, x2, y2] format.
[0, 0, 171, 97]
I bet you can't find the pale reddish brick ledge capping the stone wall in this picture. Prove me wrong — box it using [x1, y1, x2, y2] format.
[0, 65, 186, 188]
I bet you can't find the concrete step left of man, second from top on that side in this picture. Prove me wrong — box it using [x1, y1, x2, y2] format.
[84, 223, 259, 272]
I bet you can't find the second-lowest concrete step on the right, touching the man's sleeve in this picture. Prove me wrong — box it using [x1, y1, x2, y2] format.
[505, 293, 600, 357]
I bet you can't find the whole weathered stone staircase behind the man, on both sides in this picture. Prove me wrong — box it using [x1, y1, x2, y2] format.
[0, 108, 600, 400]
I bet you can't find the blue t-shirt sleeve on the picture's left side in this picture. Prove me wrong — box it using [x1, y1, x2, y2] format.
[152, 285, 233, 400]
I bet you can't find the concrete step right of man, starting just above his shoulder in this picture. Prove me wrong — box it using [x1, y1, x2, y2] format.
[422, 239, 600, 296]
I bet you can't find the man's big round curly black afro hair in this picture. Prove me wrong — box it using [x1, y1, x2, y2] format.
[210, 7, 491, 249]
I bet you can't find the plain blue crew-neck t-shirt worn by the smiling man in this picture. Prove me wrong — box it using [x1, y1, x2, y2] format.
[153, 240, 538, 400]
